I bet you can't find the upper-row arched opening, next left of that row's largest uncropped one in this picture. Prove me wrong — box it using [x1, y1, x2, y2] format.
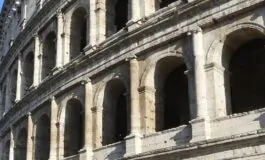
[41, 32, 56, 80]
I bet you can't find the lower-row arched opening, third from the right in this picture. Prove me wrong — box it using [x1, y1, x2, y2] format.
[103, 79, 130, 145]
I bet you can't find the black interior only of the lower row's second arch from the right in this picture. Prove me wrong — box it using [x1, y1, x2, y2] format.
[164, 65, 190, 129]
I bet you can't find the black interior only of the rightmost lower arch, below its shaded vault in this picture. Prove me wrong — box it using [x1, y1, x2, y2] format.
[229, 39, 265, 113]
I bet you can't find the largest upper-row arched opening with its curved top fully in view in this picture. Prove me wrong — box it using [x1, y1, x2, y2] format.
[70, 8, 87, 59]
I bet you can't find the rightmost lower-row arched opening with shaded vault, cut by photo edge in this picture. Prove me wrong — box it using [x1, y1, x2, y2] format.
[219, 28, 265, 114]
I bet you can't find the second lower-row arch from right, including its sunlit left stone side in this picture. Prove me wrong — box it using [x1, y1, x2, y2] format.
[141, 55, 190, 131]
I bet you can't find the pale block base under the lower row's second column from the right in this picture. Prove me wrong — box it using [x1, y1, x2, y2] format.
[124, 134, 142, 157]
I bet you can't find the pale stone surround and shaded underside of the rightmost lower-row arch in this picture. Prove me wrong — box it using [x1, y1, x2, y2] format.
[206, 23, 265, 116]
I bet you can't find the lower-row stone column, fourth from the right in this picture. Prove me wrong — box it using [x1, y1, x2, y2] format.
[49, 97, 59, 160]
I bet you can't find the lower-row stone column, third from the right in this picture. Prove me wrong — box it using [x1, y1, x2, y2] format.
[82, 81, 93, 160]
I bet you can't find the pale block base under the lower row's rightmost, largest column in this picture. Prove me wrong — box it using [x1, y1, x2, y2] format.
[190, 119, 210, 142]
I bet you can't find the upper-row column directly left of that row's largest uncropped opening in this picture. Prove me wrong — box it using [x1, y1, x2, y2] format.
[56, 10, 64, 69]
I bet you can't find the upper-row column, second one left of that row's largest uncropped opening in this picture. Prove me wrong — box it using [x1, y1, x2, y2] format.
[33, 34, 41, 87]
